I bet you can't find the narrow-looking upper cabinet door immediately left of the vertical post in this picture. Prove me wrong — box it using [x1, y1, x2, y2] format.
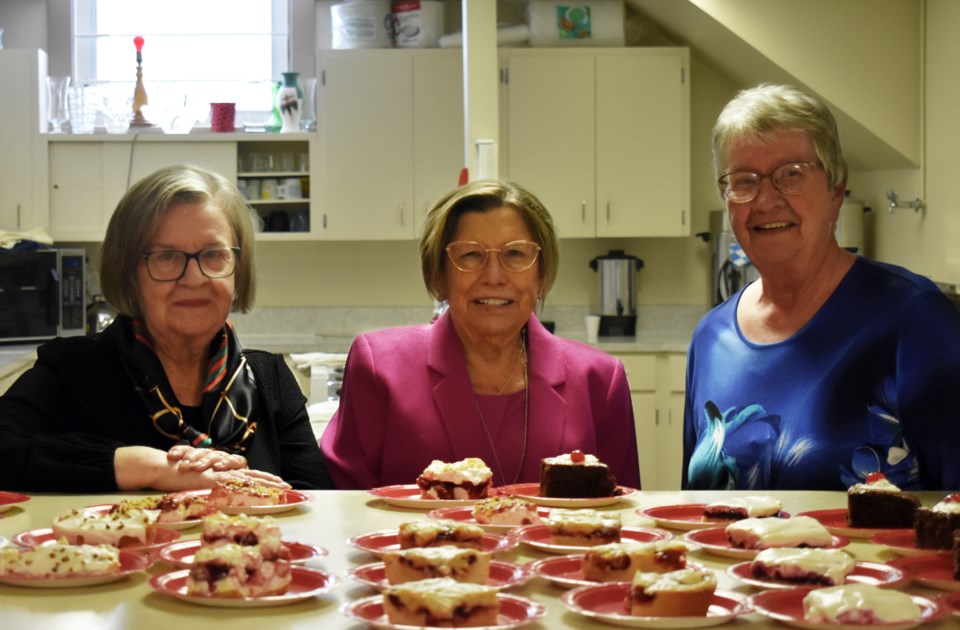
[413, 51, 466, 235]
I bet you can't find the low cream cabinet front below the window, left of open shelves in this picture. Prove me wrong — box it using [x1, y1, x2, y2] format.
[49, 135, 237, 241]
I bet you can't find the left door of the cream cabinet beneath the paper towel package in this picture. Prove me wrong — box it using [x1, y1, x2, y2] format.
[507, 54, 596, 237]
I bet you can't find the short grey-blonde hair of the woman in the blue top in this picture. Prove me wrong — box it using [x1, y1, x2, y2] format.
[713, 83, 847, 193]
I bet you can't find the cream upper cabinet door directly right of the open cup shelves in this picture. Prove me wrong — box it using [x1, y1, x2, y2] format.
[314, 51, 414, 240]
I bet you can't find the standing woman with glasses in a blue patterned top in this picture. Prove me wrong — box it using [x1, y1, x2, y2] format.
[683, 85, 960, 490]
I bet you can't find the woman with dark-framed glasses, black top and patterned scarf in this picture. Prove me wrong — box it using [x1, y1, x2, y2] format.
[0, 166, 330, 492]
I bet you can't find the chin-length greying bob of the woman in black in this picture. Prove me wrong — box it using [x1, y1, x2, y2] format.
[100, 165, 256, 317]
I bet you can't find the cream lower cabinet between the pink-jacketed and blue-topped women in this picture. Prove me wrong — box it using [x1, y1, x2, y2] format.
[615, 352, 686, 490]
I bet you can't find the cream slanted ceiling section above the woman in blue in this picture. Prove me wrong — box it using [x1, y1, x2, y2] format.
[626, 0, 923, 170]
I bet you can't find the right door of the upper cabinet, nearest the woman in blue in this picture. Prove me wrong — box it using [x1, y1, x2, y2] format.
[596, 54, 690, 237]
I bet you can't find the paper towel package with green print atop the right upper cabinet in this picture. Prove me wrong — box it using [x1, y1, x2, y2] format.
[527, 0, 626, 47]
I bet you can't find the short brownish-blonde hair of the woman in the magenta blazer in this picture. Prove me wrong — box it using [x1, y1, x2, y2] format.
[420, 179, 560, 300]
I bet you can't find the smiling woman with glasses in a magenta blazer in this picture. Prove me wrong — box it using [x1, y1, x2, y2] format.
[321, 180, 640, 489]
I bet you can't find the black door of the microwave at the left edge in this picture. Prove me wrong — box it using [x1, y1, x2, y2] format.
[0, 251, 60, 339]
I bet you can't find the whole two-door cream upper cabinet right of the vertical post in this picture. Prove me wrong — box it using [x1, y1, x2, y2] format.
[502, 48, 690, 238]
